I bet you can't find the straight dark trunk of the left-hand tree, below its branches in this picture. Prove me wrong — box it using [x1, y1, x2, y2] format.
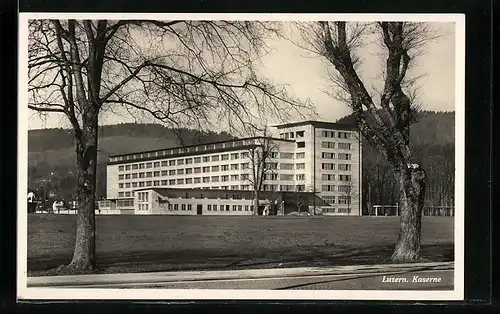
[69, 118, 97, 271]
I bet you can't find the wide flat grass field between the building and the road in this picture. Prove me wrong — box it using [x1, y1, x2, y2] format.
[28, 214, 454, 276]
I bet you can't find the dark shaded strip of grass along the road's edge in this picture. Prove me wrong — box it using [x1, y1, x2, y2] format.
[28, 243, 454, 276]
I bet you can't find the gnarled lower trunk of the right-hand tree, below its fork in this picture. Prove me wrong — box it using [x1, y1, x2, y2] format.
[392, 168, 425, 262]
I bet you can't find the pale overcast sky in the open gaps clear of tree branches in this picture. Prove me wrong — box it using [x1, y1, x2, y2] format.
[28, 23, 455, 129]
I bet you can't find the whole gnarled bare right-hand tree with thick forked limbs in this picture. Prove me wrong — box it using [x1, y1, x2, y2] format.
[297, 21, 435, 261]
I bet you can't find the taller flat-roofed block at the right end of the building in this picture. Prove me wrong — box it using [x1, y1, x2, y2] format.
[276, 121, 362, 215]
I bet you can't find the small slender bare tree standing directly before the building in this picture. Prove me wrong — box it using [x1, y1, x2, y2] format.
[244, 127, 279, 215]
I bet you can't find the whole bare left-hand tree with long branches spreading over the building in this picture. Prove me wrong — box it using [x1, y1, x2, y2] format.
[28, 20, 311, 271]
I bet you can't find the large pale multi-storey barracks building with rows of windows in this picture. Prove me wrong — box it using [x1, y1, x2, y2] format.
[99, 121, 361, 215]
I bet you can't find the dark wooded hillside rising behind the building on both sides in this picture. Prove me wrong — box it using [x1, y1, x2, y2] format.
[28, 111, 455, 208]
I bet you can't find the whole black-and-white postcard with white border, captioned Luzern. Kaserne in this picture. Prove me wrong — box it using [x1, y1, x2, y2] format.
[17, 13, 465, 300]
